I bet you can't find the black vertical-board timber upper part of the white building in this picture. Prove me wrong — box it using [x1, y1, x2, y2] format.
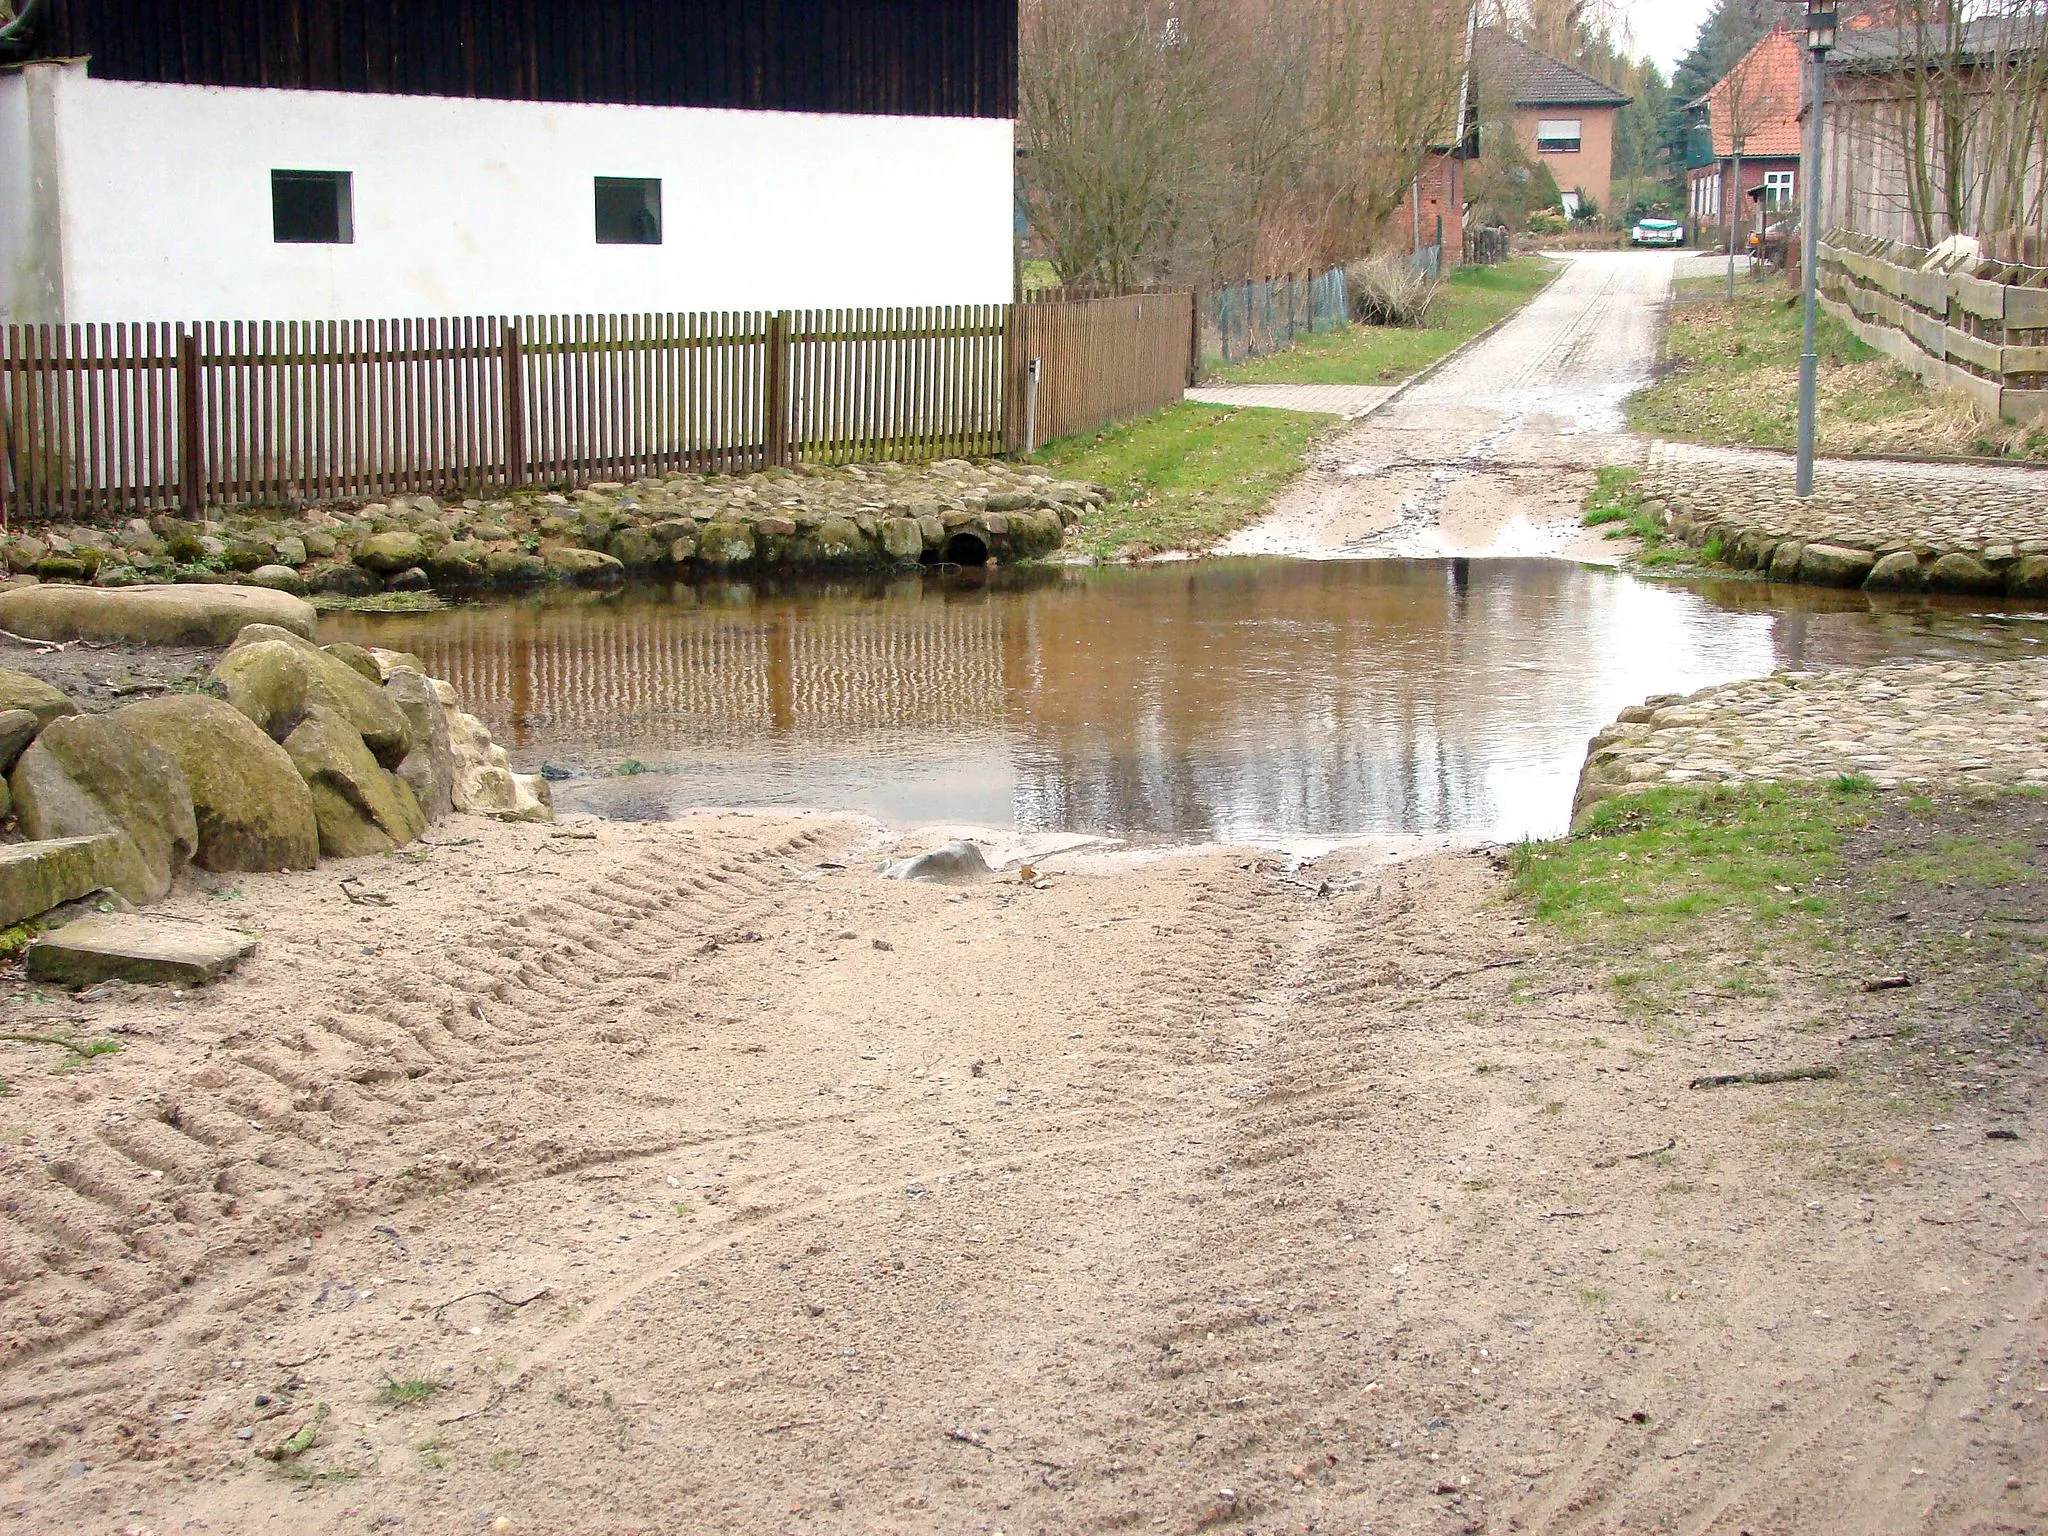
[9, 0, 1018, 117]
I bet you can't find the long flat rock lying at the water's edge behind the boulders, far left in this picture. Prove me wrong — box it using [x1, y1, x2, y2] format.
[0, 582, 315, 645]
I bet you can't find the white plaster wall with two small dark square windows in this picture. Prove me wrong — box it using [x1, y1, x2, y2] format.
[41, 68, 1014, 322]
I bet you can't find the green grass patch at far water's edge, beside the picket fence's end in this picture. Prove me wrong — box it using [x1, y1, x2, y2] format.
[1032, 401, 1335, 559]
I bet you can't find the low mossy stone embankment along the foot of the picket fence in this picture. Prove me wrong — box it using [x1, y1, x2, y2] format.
[0, 459, 1106, 596]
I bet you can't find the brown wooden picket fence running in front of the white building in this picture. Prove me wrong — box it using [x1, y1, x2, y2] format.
[0, 293, 1192, 520]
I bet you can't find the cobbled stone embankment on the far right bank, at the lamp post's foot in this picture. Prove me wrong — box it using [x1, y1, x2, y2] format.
[1642, 442, 2048, 598]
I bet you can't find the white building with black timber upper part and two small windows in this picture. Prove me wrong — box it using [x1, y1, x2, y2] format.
[0, 0, 1016, 324]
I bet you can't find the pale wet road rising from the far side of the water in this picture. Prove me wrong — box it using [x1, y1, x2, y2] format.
[1219, 252, 1690, 561]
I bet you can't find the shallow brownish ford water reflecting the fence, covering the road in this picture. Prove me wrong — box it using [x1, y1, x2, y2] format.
[322, 559, 2048, 842]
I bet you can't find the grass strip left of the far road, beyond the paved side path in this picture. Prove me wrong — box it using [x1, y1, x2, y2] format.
[1214, 256, 1556, 385]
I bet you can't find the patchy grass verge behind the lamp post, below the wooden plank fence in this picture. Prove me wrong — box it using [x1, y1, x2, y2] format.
[1628, 276, 2048, 459]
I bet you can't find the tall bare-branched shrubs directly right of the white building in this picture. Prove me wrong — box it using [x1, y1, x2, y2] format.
[1018, 0, 1470, 287]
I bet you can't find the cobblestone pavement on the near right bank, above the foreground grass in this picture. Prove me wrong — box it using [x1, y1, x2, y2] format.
[1573, 659, 2048, 825]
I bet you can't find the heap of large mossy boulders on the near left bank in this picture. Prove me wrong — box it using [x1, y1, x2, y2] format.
[0, 586, 551, 963]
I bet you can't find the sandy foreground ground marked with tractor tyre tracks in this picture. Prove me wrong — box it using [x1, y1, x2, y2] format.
[0, 813, 2048, 1536]
